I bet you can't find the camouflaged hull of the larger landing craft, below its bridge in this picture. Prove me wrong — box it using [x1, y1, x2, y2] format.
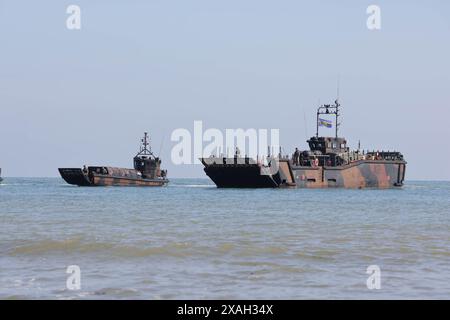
[201, 159, 406, 189]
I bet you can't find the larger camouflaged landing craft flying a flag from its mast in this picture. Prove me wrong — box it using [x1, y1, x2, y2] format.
[200, 100, 406, 188]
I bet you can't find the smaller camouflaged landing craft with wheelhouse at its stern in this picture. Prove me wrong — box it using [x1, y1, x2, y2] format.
[58, 132, 169, 187]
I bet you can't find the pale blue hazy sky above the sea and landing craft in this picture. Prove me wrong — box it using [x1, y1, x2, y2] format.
[0, 0, 450, 180]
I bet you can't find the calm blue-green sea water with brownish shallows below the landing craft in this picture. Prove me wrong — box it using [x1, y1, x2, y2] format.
[0, 178, 450, 299]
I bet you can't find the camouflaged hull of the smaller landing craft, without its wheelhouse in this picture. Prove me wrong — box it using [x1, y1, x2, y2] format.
[58, 167, 169, 187]
